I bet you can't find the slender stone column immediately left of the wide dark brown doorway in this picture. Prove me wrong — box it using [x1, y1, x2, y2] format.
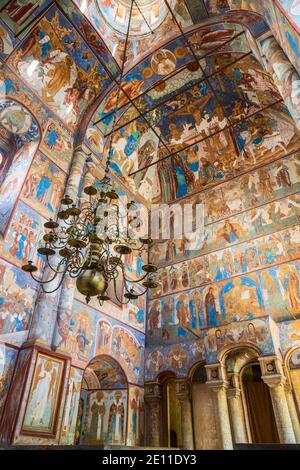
[227, 375, 248, 443]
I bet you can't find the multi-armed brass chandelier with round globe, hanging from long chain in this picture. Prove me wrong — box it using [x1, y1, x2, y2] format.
[22, 2, 158, 306]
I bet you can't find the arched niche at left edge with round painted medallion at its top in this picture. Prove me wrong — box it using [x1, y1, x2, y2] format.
[0, 98, 41, 238]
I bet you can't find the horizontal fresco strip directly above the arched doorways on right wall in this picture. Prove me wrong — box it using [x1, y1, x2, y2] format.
[145, 318, 274, 380]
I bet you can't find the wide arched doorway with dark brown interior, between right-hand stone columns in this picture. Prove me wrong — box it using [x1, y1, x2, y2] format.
[240, 363, 280, 444]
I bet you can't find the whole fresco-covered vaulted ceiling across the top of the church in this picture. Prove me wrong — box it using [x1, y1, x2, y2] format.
[0, 0, 297, 202]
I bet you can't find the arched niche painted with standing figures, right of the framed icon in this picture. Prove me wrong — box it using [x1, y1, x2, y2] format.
[77, 355, 128, 445]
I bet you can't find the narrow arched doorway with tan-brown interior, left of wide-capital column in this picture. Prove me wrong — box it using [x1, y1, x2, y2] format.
[191, 364, 220, 450]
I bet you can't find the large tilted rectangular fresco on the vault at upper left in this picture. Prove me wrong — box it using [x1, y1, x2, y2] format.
[8, 8, 110, 128]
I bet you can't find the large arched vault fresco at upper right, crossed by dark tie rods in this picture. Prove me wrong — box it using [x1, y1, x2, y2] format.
[85, 28, 298, 202]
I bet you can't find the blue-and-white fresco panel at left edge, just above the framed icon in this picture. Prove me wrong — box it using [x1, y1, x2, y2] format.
[0, 260, 37, 343]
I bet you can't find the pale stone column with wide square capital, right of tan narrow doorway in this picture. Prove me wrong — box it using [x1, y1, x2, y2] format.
[205, 364, 233, 450]
